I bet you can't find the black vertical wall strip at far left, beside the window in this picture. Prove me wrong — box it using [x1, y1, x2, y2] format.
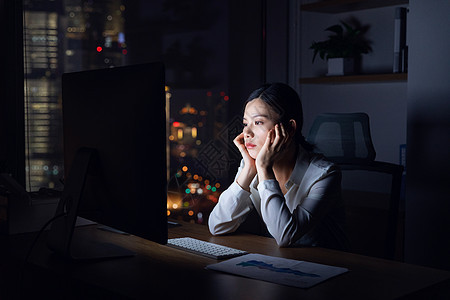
[0, 0, 25, 186]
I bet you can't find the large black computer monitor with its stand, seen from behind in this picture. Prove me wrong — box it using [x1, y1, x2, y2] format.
[47, 63, 167, 258]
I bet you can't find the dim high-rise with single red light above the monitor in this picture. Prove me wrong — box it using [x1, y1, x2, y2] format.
[64, 0, 128, 72]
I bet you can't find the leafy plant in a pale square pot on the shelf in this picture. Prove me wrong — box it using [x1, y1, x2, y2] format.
[310, 20, 372, 76]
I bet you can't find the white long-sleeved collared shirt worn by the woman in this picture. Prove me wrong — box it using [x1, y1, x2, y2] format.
[208, 150, 348, 249]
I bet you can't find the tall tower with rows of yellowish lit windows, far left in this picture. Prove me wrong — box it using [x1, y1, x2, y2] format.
[24, 1, 62, 190]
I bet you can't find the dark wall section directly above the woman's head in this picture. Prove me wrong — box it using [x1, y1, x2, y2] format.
[229, 0, 289, 117]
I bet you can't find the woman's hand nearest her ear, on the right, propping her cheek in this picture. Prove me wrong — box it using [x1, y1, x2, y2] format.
[256, 123, 291, 179]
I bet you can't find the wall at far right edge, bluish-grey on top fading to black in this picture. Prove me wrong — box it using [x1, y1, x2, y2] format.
[405, 0, 450, 269]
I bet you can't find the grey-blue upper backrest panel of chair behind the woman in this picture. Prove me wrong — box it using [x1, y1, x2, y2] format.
[307, 113, 376, 164]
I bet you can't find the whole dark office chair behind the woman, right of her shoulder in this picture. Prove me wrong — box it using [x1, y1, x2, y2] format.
[307, 113, 403, 259]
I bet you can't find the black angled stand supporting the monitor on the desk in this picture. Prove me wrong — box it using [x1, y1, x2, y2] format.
[47, 148, 136, 260]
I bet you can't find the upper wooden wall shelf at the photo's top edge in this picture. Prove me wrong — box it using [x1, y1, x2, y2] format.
[300, 0, 409, 14]
